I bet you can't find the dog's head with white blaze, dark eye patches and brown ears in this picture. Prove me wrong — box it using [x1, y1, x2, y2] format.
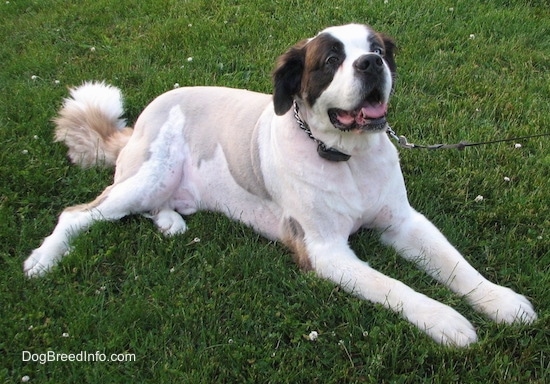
[273, 24, 395, 138]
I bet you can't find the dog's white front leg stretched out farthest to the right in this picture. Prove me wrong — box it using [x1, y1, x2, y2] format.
[382, 209, 537, 323]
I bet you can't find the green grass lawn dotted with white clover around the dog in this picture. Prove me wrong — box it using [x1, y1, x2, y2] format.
[0, 0, 550, 383]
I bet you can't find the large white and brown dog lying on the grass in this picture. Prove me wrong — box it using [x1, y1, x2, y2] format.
[24, 24, 537, 347]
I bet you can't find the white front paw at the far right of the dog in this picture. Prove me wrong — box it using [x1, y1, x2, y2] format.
[467, 283, 537, 324]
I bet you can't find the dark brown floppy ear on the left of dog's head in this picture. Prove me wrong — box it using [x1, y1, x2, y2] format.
[273, 40, 307, 116]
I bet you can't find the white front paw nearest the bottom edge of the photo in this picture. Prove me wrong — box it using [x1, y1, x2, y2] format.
[404, 297, 477, 347]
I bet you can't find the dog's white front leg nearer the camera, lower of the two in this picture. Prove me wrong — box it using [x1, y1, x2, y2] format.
[307, 240, 477, 347]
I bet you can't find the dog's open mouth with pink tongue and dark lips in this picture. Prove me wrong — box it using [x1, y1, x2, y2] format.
[328, 92, 388, 131]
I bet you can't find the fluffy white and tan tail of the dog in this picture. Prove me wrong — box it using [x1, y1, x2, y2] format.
[53, 82, 133, 168]
